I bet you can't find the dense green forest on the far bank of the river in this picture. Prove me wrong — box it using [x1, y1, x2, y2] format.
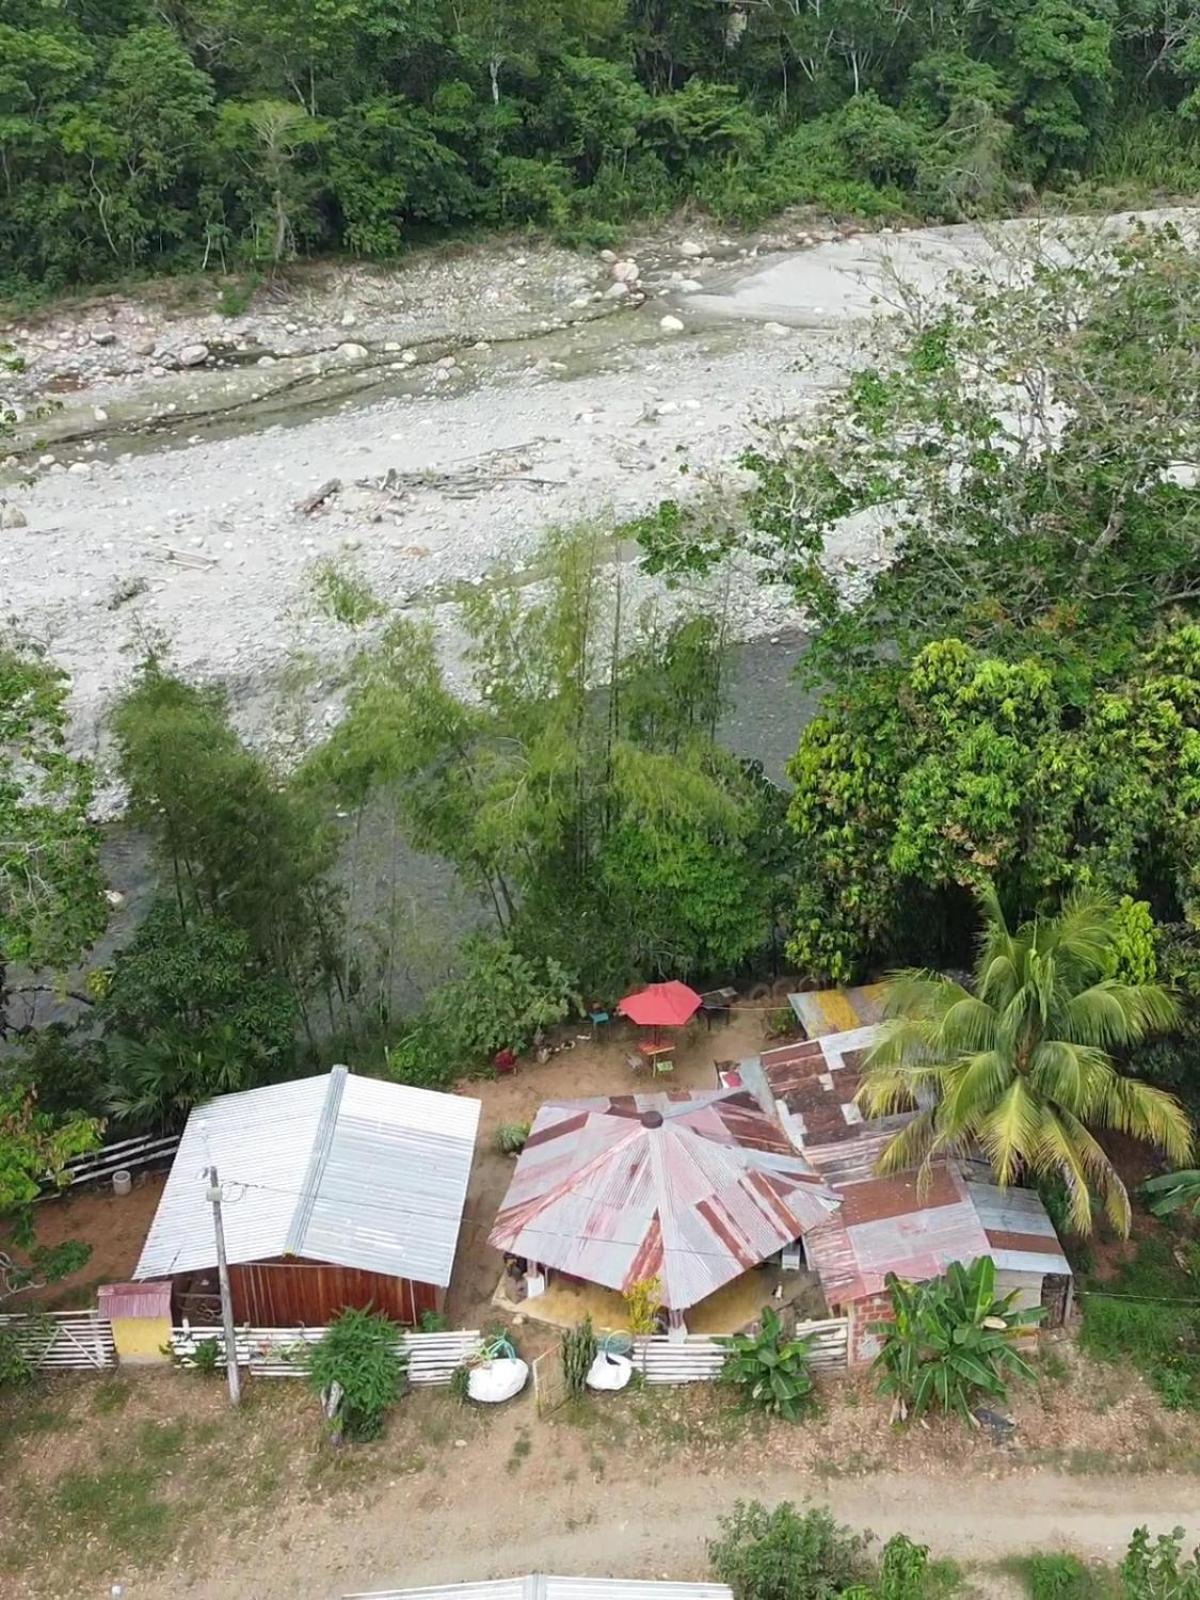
[0, 0, 1200, 293]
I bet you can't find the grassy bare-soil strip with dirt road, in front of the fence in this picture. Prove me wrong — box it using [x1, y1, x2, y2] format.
[0, 1346, 1200, 1600]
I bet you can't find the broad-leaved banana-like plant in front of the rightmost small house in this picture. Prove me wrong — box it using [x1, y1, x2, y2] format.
[872, 1256, 1043, 1422]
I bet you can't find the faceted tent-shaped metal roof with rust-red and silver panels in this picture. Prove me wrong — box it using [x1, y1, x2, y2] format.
[490, 1090, 837, 1310]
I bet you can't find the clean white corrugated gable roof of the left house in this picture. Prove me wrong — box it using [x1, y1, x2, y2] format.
[134, 1067, 480, 1286]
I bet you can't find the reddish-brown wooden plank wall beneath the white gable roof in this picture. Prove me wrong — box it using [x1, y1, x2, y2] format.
[229, 1261, 445, 1328]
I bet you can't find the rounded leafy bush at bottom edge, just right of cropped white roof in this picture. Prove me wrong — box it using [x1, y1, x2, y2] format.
[709, 1501, 867, 1600]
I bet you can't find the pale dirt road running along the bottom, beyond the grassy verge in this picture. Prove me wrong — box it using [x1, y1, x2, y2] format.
[190, 1465, 1200, 1600]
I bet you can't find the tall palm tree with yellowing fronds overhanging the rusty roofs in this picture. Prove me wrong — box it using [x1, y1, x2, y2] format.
[858, 888, 1192, 1235]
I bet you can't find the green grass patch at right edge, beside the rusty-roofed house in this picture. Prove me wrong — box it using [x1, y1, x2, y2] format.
[1080, 1230, 1200, 1411]
